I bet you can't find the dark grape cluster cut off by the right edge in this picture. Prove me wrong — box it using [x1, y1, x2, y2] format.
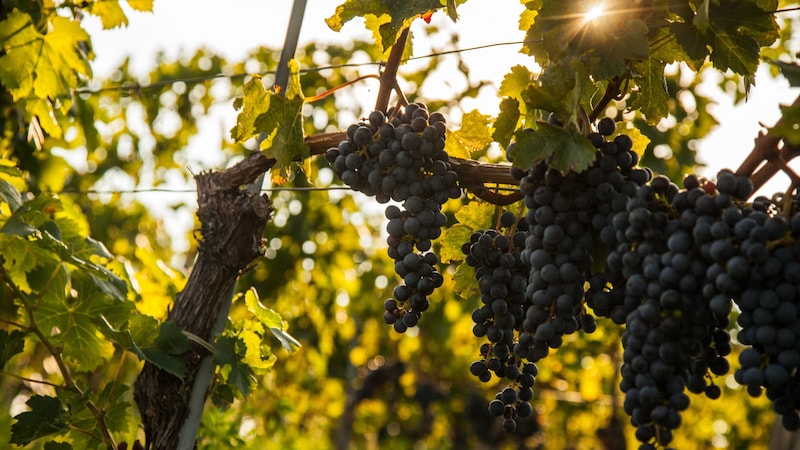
[729, 198, 800, 431]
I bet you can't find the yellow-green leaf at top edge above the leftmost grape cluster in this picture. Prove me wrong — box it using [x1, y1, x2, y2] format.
[325, 0, 450, 52]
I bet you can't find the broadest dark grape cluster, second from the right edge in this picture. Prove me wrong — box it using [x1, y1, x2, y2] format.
[592, 171, 752, 449]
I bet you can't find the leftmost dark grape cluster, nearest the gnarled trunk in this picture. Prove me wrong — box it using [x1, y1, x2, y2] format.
[326, 103, 461, 333]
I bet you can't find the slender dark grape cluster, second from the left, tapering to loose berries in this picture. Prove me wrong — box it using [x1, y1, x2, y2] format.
[461, 211, 538, 432]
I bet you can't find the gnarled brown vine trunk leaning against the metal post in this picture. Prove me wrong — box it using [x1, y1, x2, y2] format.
[134, 153, 275, 450]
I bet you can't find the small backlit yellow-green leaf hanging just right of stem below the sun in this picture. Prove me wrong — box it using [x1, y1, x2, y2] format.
[631, 58, 669, 125]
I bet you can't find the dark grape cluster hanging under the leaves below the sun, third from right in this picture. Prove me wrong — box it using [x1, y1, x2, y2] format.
[520, 119, 651, 361]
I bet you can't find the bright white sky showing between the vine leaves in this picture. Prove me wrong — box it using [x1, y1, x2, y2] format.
[79, 0, 800, 251]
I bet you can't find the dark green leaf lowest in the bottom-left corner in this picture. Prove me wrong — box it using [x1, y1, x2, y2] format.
[8, 395, 69, 445]
